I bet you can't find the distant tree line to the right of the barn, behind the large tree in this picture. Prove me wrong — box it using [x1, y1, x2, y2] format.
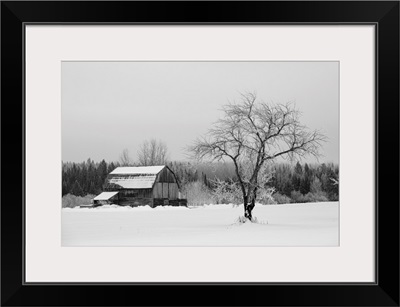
[177, 162, 339, 204]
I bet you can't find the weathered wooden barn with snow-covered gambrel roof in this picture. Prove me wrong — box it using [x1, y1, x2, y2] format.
[93, 165, 187, 207]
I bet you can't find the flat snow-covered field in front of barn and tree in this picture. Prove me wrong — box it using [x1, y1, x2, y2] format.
[61, 202, 339, 246]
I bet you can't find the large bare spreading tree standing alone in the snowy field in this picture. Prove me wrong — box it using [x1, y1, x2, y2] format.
[189, 93, 325, 221]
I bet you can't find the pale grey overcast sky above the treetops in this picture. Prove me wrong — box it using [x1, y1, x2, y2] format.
[62, 62, 339, 163]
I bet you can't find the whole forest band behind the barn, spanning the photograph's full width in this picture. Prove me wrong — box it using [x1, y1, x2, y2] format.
[62, 159, 339, 207]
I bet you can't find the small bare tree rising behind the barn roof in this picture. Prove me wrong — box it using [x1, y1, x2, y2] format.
[137, 139, 168, 166]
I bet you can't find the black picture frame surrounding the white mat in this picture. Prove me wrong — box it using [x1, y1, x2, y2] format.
[1, 1, 399, 306]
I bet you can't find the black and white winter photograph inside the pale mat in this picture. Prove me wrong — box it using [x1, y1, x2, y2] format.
[60, 61, 340, 247]
